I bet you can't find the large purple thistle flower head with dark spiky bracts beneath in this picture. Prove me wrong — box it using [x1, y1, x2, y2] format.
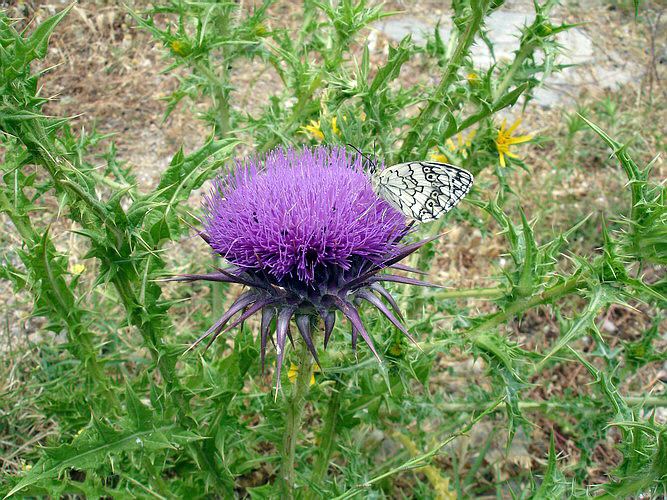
[171, 146, 434, 387]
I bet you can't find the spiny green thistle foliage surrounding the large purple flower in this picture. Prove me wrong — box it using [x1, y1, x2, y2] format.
[0, 0, 667, 498]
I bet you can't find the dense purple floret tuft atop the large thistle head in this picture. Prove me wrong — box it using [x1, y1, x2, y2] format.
[204, 148, 406, 283]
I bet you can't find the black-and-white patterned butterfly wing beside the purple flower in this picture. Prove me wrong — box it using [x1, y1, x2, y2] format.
[372, 161, 473, 222]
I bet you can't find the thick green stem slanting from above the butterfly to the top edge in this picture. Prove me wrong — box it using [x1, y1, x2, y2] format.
[400, 0, 489, 158]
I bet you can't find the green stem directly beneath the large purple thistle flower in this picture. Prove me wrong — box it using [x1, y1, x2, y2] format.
[280, 342, 313, 499]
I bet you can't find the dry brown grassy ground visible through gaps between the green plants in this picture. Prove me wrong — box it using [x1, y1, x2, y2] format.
[0, 1, 667, 492]
